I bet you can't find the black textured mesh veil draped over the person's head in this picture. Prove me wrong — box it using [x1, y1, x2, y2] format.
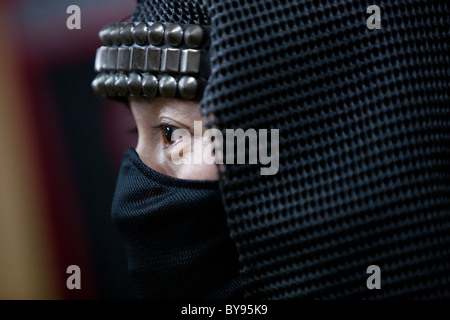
[134, 0, 450, 299]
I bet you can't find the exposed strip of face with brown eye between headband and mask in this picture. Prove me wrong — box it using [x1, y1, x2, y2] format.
[129, 97, 218, 180]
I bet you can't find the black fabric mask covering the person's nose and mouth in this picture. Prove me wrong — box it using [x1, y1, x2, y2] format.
[112, 149, 240, 299]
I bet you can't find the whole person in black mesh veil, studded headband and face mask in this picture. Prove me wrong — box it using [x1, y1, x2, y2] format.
[93, 0, 450, 299]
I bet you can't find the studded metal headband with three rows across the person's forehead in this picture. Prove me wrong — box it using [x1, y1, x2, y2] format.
[92, 22, 210, 99]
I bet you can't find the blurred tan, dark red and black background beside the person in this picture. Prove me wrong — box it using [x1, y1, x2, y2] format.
[0, 0, 137, 299]
